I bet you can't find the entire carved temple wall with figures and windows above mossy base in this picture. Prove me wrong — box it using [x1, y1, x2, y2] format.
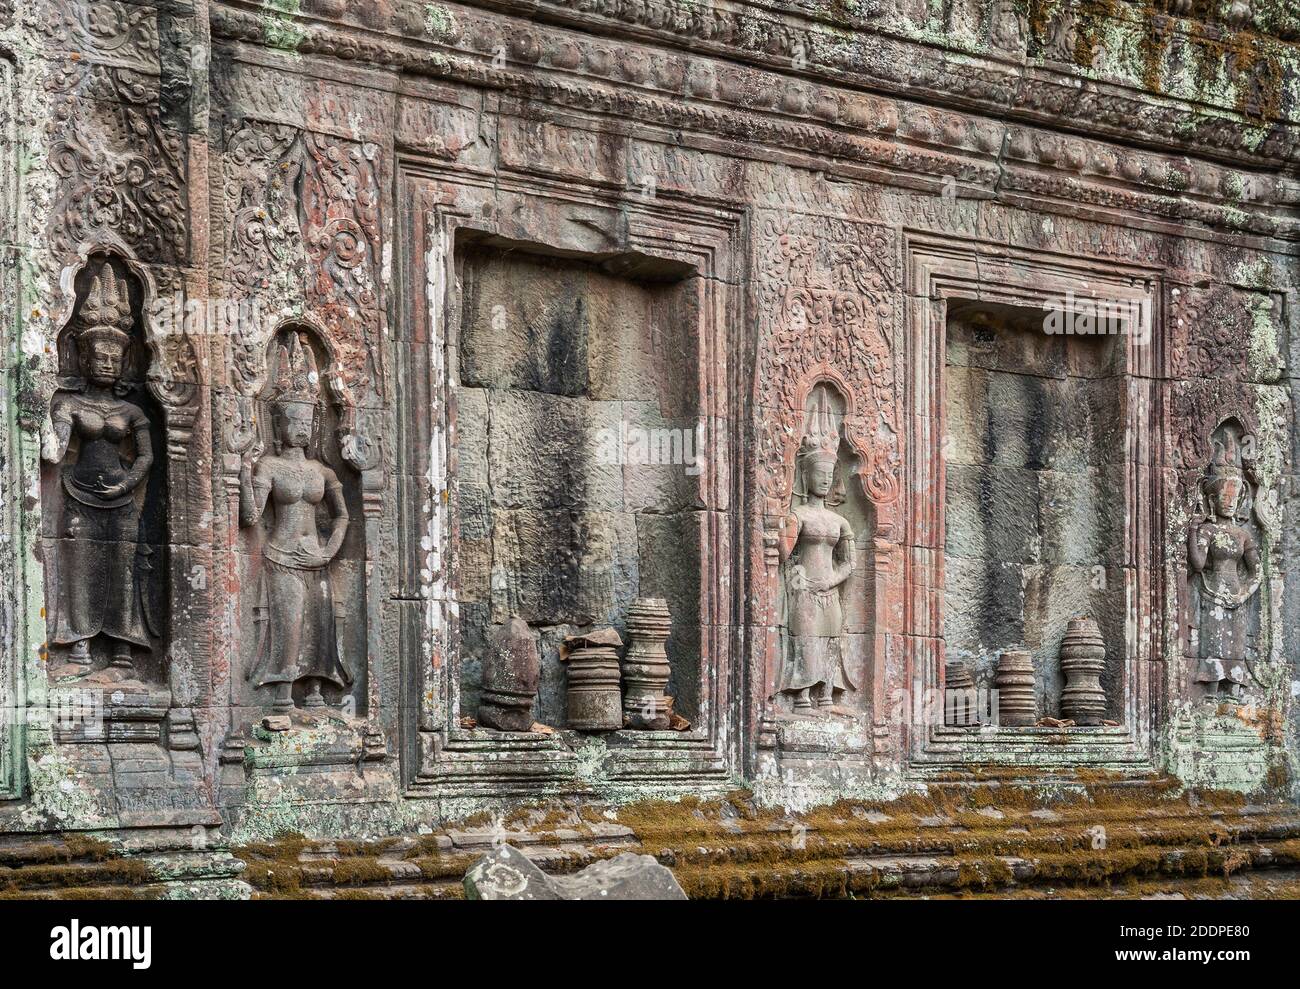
[0, 0, 1300, 847]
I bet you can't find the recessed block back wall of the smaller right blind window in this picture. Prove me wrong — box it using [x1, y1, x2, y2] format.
[944, 303, 1126, 720]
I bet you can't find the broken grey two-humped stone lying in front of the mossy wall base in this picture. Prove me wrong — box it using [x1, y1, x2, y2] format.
[464, 845, 686, 899]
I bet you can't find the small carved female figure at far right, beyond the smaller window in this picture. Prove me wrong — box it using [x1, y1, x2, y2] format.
[1187, 446, 1260, 698]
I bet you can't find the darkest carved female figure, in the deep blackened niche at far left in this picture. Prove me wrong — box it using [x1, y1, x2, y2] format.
[42, 264, 153, 681]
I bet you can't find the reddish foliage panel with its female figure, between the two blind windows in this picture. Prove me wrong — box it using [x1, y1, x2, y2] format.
[754, 218, 901, 715]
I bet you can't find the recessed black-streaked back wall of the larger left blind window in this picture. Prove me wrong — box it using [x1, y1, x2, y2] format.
[449, 235, 707, 725]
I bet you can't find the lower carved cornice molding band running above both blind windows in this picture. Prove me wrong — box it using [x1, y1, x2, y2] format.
[213, 5, 1300, 239]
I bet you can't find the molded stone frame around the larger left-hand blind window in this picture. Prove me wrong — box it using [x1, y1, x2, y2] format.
[393, 137, 744, 798]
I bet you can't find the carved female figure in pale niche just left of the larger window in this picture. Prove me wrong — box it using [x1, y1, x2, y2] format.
[239, 333, 352, 711]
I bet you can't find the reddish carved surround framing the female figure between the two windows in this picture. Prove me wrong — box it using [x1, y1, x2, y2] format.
[744, 214, 906, 785]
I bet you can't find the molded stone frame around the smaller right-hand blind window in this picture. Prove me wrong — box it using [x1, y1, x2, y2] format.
[901, 233, 1167, 775]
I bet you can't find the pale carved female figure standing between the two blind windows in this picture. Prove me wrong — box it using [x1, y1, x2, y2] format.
[777, 430, 854, 713]
